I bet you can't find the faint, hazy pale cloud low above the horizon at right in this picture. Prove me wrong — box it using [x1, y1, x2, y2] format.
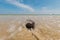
[36, 7, 60, 14]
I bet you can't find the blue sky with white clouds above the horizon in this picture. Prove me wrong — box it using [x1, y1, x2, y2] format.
[0, 0, 60, 14]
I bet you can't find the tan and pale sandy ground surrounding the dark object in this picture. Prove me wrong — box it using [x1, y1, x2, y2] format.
[0, 15, 60, 40]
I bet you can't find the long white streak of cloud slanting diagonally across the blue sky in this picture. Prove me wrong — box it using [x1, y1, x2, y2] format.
[6, 0, 34, 12]
